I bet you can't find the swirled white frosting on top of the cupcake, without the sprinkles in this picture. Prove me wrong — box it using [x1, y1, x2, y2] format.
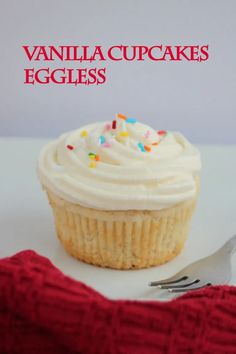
[38, 119, 201, 210]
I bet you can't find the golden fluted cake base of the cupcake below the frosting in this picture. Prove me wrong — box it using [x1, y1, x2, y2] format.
[47, 191, 196, 269]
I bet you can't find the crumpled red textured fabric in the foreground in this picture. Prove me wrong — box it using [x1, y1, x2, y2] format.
[0, 251, 236, 354]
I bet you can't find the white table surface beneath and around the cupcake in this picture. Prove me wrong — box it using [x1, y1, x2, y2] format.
[0, 138, 236, 299]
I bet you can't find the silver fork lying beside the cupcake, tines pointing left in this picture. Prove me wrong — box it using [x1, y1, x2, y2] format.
[149, 235, 236, 293]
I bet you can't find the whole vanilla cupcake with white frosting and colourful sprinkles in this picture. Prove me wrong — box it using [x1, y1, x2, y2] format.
[38, 114, 201, 269]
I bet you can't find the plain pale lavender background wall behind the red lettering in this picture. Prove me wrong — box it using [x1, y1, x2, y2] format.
[0, 0, 236, 144]
